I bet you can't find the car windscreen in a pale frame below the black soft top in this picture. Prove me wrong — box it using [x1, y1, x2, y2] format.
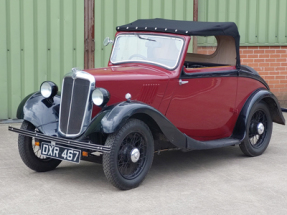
[111, 34, 183, 69]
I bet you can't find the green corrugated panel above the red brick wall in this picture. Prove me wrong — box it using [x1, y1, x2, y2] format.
[198, 0, 287, 46]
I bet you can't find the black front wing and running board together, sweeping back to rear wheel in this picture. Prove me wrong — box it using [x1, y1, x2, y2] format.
[93, 101, 240, 150]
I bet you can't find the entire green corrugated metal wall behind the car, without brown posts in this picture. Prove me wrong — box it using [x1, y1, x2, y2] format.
[6, 0, 287, 119]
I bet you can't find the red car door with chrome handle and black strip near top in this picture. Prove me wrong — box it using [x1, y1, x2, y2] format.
[166, 66, 238, 140]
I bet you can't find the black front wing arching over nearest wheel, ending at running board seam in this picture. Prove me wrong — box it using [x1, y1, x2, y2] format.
[96, 101, 186, 148]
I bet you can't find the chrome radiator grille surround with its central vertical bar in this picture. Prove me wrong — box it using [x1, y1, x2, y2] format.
[58, 68, 96, 138]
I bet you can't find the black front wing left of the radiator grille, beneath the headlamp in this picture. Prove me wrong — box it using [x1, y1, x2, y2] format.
[20, 92, 60, 135]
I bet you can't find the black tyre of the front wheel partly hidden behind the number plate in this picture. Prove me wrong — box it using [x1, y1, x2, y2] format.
[18, 121, 61, 172]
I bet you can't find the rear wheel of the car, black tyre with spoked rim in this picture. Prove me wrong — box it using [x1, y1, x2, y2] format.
[240, 102, 273, 157]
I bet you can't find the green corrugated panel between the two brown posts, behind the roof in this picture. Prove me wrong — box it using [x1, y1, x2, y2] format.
[95, 0, 193, 67]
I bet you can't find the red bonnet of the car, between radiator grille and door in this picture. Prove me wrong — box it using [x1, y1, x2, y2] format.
[85, 64, 169, 117]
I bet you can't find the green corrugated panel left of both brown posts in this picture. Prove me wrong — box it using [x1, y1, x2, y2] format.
[0, 0, 84, 119]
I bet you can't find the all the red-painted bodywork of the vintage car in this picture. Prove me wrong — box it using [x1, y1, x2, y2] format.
[85, 32, 265, 140]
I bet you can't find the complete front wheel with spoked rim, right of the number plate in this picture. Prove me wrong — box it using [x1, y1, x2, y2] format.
[103, 119, 154, 190]
